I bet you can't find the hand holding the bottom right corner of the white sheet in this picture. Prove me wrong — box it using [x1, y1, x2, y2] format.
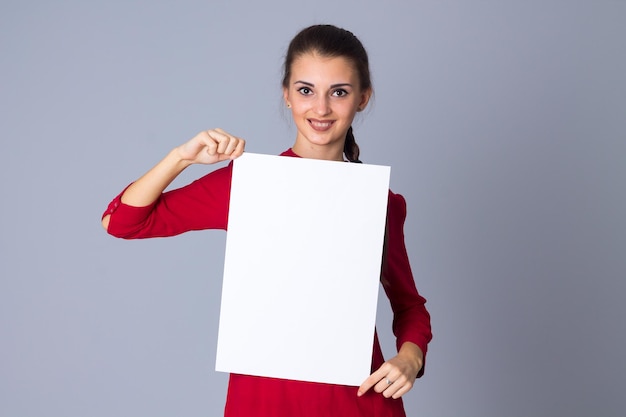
[358, 342, 424, 398]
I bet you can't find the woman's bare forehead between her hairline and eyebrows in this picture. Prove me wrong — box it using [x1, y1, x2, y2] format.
[290, 53, 358, 86]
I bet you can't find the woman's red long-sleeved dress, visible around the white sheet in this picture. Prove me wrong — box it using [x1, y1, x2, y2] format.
[103, 149, 432, 417]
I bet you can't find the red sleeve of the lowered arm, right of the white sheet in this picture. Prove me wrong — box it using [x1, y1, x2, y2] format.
[382, 191, 432, 377]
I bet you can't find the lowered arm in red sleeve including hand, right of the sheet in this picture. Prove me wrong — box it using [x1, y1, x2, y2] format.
[359, 192, 432, 398]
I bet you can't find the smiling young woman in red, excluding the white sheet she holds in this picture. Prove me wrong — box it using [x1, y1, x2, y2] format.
[102, 25, 432, 417]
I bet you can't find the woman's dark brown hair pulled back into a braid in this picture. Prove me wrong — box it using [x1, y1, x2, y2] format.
[283, 25, 372, 162]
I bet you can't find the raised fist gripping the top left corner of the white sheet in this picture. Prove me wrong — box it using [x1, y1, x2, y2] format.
[176, 128, 246, 164]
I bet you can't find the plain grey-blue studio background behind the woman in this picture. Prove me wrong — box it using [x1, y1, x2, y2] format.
[0, 0, 626, 417]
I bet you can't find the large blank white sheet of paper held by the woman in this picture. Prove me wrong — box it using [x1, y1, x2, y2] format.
[216, 153, 390, 386]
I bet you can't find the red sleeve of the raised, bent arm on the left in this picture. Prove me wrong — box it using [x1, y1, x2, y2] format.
[102, 162, 232, 239]
